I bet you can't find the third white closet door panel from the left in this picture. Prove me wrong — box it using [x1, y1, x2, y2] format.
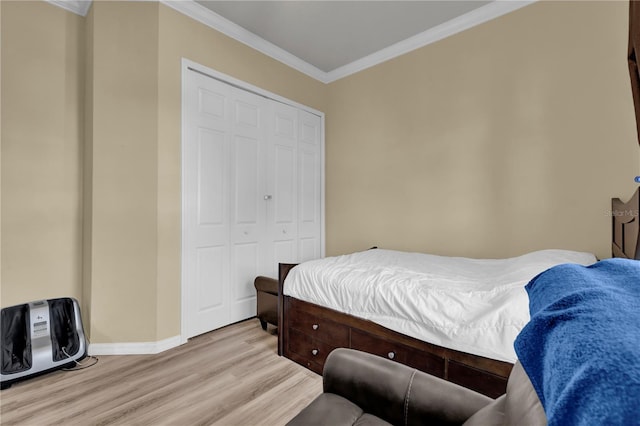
[267, 102, 298, 277]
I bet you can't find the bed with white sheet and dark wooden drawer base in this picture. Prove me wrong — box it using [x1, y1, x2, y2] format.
[278, 249, 597, 397]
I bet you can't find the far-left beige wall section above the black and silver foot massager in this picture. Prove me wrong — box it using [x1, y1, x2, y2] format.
[0, 1, 84, 306]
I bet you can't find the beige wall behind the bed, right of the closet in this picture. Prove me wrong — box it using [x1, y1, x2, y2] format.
[326, 2, 640, 257]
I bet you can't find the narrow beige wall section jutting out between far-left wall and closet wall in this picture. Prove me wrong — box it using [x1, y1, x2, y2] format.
[85, 1, 159, 343]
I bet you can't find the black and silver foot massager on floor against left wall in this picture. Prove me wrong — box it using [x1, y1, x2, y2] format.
[0, 297, 87, 389]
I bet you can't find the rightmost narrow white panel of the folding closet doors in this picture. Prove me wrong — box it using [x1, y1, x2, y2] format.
[297, 110, 322, 262]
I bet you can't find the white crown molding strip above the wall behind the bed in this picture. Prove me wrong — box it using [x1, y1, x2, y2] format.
[325, 0, 537, 83]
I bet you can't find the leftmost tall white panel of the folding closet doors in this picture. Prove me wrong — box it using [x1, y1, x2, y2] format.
[182, 72, 232, 337]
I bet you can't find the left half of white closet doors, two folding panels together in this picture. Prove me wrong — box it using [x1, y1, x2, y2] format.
[183, 73, 269, 337]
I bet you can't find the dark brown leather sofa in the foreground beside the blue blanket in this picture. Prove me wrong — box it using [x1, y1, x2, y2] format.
[288, 349, 547, 426]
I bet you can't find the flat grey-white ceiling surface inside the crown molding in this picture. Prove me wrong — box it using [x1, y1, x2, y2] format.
[196, 0, 489, 72]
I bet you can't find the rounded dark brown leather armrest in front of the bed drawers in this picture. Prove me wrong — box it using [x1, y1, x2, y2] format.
[323, 348, 493, 424]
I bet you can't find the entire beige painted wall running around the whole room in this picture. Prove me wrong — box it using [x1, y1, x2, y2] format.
[0, 1, 640, 343]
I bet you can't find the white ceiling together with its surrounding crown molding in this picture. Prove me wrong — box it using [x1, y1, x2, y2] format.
[47, 0, 535, 83]
